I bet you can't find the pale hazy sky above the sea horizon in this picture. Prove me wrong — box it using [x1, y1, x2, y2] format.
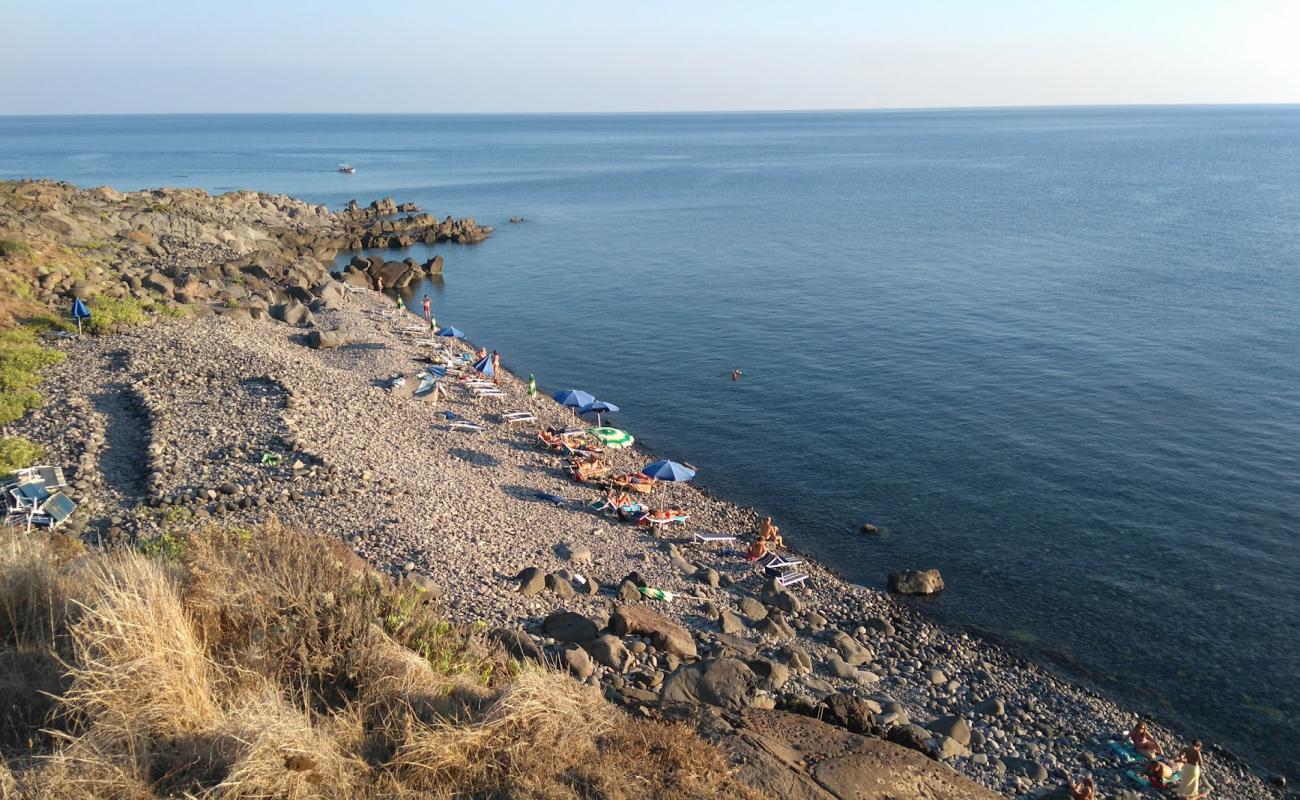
[0, 0, 1300, 113]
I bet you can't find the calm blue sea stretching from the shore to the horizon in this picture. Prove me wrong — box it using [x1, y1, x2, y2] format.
[0, 108, 1300, 769]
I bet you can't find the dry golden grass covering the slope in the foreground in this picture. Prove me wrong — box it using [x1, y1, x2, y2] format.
[0, 527, 750, 800]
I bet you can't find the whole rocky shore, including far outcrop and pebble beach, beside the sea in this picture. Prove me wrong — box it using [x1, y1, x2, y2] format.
[0, 183, 1277, 799]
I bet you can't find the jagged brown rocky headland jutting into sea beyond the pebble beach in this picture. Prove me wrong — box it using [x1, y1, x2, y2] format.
[0, 181, 491, 323]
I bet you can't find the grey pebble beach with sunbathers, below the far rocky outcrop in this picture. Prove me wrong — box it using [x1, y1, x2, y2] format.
[7, 290, 1274, 797]
